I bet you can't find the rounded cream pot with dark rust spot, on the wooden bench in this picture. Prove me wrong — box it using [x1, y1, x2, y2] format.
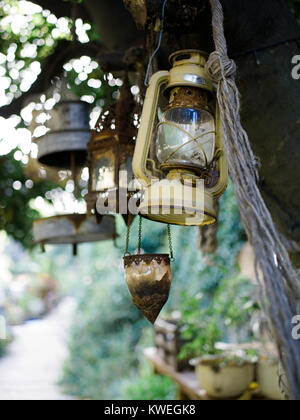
[196, 358, 254, 399]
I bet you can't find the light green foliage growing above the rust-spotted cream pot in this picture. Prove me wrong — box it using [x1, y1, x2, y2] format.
[181, 276, 258, 358]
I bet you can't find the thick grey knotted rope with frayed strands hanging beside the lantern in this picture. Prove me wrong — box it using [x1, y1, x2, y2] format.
[207, 0, 300, 400]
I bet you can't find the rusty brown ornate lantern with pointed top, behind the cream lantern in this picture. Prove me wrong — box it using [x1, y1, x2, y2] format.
[85, 77, 139, 223]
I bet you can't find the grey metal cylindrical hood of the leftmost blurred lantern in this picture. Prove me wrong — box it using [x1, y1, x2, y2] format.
[36, 101, 91, 169]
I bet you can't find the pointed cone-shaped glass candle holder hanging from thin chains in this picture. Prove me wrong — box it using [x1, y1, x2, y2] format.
[124, 217, 173, 324]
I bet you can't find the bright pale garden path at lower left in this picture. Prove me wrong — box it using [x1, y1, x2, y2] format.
[0, 298, 74, 401]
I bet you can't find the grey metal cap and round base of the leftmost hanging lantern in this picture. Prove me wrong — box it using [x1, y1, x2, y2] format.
[33, 76, 117, 255]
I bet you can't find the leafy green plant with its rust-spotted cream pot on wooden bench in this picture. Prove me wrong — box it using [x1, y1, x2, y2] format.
[181, 276, 258, 399]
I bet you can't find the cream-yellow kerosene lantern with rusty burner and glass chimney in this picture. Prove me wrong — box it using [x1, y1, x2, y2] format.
[133, 50, 228, 226]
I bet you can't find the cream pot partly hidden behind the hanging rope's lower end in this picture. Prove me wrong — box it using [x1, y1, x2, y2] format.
[257, 361, 285, 401]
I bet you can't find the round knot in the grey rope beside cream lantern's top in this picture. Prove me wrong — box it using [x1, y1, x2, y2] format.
[206, 51, 237, 83]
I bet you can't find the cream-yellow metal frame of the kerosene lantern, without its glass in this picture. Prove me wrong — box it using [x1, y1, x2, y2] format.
[133, 50, 228, 226]
